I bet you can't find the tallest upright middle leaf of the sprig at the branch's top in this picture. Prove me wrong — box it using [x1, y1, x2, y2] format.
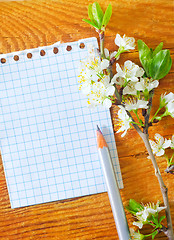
[92, 2, 103, 29]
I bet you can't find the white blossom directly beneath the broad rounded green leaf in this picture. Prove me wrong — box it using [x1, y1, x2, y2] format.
[135, 78, 159, 92]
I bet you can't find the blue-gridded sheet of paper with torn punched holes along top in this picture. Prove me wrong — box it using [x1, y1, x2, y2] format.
[0, 38, 123, 208]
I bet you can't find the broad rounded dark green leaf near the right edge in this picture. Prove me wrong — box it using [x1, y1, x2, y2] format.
[149, 49, 172, 80]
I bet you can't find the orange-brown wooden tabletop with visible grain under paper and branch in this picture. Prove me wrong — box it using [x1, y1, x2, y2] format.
[0, 0, 174, 240]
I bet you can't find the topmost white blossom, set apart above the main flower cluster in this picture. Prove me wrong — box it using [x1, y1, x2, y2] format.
[115, 33, 135, 50]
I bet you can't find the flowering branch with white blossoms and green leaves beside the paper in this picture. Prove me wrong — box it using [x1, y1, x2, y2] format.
[79, 2, 174, 237]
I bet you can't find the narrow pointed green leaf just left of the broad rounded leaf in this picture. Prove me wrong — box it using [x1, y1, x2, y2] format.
[137, 40, 152, 77]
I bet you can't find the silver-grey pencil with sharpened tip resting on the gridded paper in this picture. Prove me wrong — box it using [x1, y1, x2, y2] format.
[97, 126, 131, 240]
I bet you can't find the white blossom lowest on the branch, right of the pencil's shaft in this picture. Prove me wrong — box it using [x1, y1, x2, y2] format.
[133, 202, 165, 229]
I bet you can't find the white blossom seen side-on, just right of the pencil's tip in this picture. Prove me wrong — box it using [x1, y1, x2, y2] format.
[117, 106, 132, 137]
